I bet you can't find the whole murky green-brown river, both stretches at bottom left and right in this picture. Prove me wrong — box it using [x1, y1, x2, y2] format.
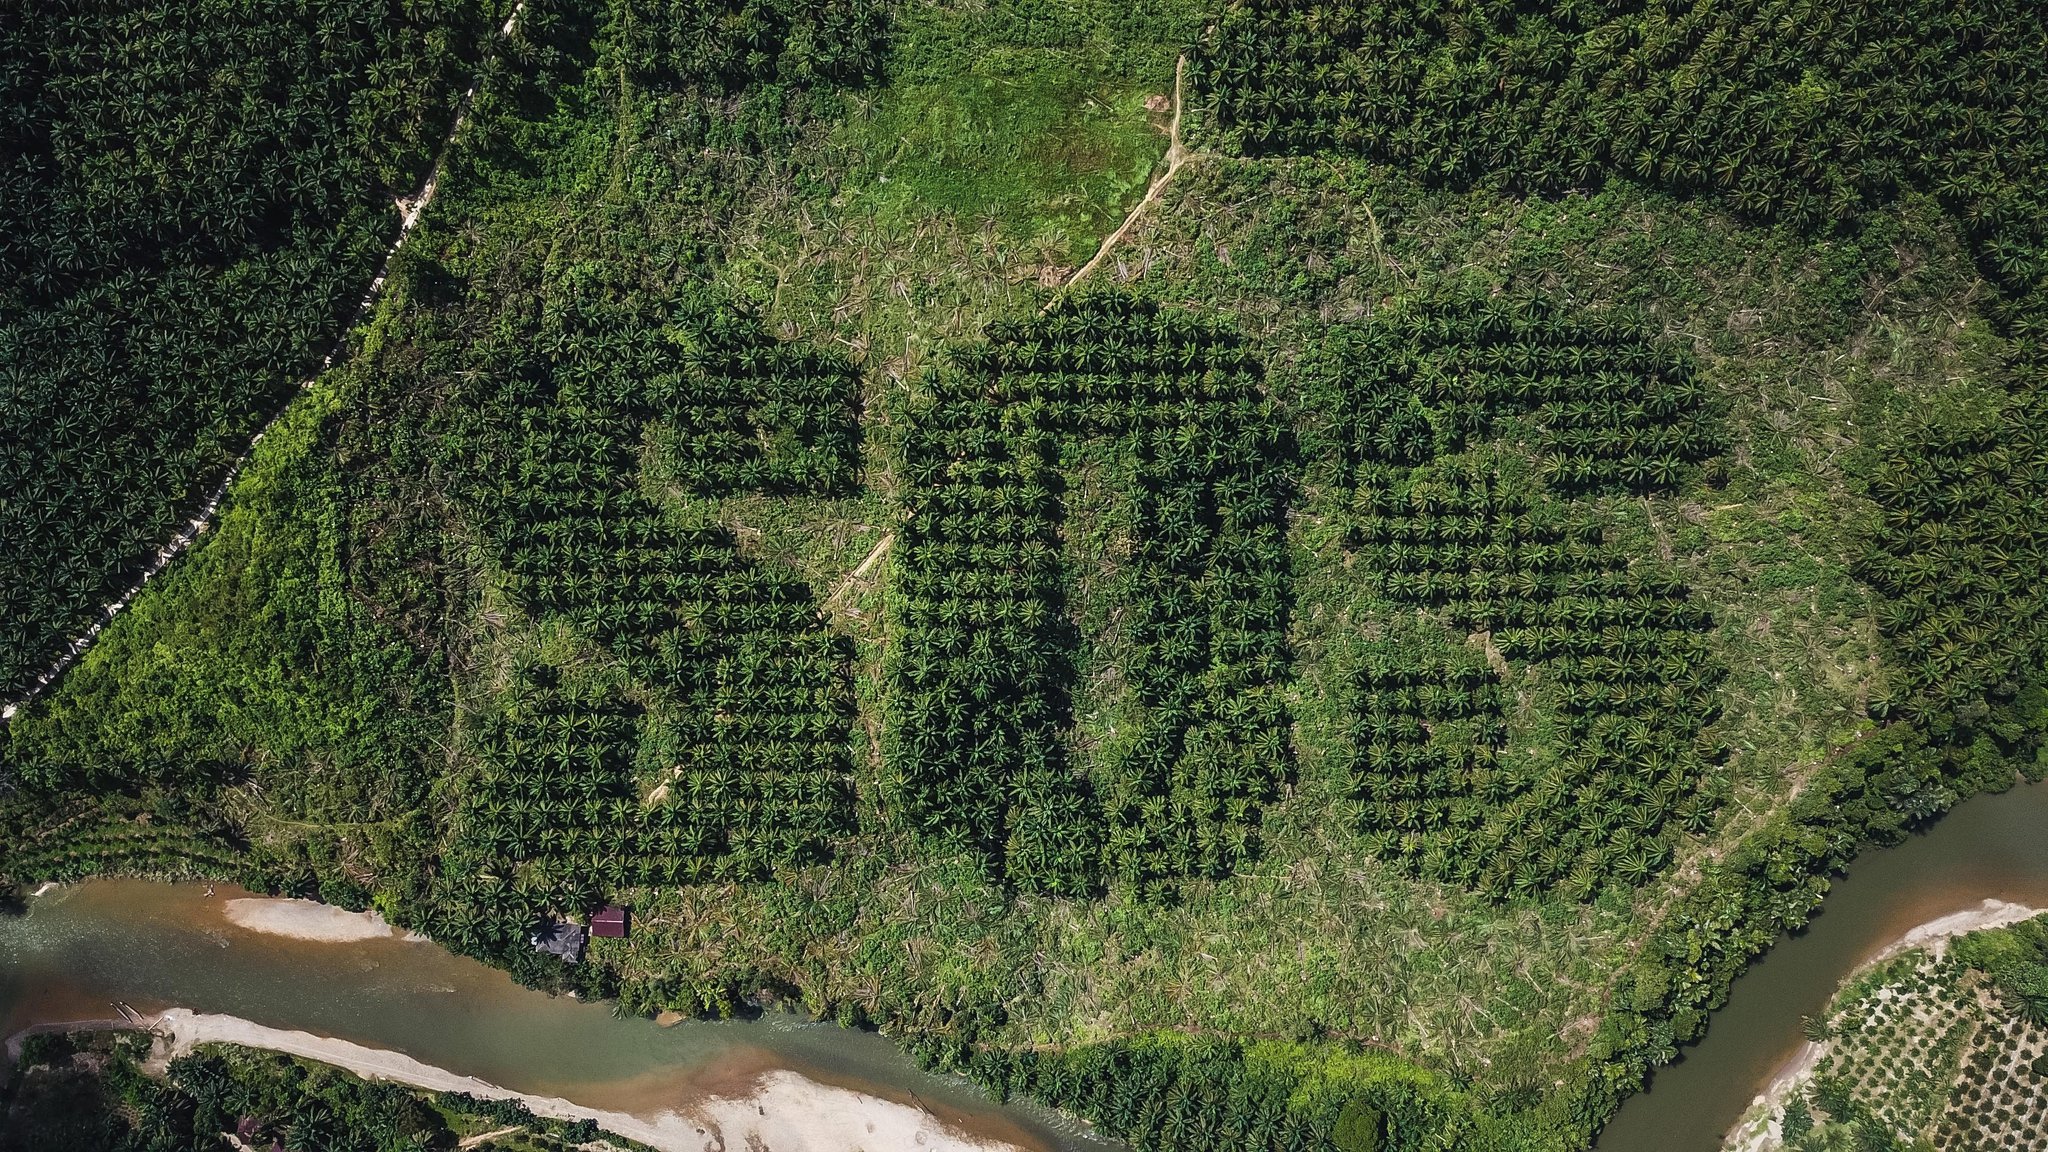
[0, 785, 2048, 1152]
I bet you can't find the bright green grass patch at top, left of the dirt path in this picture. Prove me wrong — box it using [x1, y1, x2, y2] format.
[817, 0, 1200, 262]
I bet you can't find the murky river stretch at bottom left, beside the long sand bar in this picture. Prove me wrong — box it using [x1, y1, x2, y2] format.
[0, 879, 1110, 1152]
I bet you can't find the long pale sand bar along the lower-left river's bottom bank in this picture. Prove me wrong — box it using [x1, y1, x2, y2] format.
[156, 1009, 1016, 1152]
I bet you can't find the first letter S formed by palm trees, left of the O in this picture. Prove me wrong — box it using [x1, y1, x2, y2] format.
[438, 307, 856, 949]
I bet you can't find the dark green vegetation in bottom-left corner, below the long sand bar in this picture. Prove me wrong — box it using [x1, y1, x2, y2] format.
[0, 1033, 641, 1152]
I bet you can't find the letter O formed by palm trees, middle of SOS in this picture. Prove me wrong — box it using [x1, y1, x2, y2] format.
[885, 295, 1290, 892]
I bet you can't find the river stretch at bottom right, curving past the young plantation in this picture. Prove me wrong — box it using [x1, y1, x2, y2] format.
[1595, 770, 2048, 1152]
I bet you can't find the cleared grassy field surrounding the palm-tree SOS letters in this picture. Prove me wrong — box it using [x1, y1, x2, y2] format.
[0, 0, 2031, 1139]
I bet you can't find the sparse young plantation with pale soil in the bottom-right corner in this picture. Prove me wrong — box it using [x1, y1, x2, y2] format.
[1737, 916, 2048, 1152]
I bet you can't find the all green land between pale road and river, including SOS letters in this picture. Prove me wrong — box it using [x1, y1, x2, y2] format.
[0, 0, 2048, 1148]
